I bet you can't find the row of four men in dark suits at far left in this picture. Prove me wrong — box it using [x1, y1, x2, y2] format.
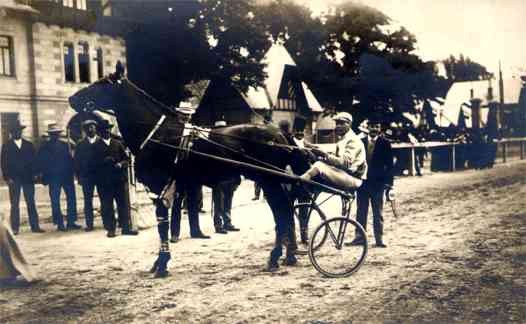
[1, 120, 137, 237]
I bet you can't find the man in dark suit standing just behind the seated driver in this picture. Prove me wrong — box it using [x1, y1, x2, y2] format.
[351, 120, 393, 248]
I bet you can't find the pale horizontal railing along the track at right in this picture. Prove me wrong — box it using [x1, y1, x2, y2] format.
[393, 138, 526, 175]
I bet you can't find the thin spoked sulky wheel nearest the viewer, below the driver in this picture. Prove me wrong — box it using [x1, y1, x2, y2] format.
[309, 217, 367, 278]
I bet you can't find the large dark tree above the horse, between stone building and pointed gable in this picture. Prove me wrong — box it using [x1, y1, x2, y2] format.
[105, 0, 269, 105]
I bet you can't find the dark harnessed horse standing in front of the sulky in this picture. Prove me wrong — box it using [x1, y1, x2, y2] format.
[69, 74, 308, 276]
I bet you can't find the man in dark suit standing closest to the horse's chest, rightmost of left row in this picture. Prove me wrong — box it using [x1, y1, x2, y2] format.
[94, 120, 138, 237]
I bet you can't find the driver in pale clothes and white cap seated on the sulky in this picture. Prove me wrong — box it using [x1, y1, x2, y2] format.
[301, 112, 367, 190]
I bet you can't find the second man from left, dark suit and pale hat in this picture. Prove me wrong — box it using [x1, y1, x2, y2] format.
[37, 123, 80, 231]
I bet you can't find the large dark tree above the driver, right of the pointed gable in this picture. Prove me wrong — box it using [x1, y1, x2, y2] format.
[325, 2, 445, 120]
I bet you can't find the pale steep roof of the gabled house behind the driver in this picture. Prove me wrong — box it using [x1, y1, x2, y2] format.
[241, 44, 323, 112]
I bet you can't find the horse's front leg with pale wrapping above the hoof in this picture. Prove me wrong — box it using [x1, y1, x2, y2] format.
[150, 199, 171, 278]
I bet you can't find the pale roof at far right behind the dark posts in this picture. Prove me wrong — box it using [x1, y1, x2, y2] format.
[438, 79, 522, 127]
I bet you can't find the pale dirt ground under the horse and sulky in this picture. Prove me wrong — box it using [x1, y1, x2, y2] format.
[0, 162, 526, 323]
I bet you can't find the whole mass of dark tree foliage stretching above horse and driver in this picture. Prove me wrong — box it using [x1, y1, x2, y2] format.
[105, 0, 452, 121]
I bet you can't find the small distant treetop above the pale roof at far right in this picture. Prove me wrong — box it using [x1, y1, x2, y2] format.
[443, 54, 493, 81]
